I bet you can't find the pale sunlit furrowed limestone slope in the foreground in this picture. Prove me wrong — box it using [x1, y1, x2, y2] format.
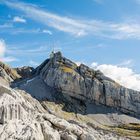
[0, 85, 127, 140]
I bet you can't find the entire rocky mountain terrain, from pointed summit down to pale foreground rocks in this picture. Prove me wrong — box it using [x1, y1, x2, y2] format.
[0, 52, 140, 140]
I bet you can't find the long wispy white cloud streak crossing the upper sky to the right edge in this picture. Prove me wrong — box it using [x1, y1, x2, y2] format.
[2, 0, 140, 39]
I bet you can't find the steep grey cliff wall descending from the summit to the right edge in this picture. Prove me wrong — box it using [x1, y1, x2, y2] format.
[36, 52, 140, 116]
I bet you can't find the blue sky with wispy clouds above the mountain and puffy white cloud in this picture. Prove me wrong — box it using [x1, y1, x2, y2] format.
[0, 0, 140, 91]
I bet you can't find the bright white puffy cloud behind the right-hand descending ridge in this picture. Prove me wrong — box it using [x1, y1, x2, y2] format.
[91, 63, 140, 91]
